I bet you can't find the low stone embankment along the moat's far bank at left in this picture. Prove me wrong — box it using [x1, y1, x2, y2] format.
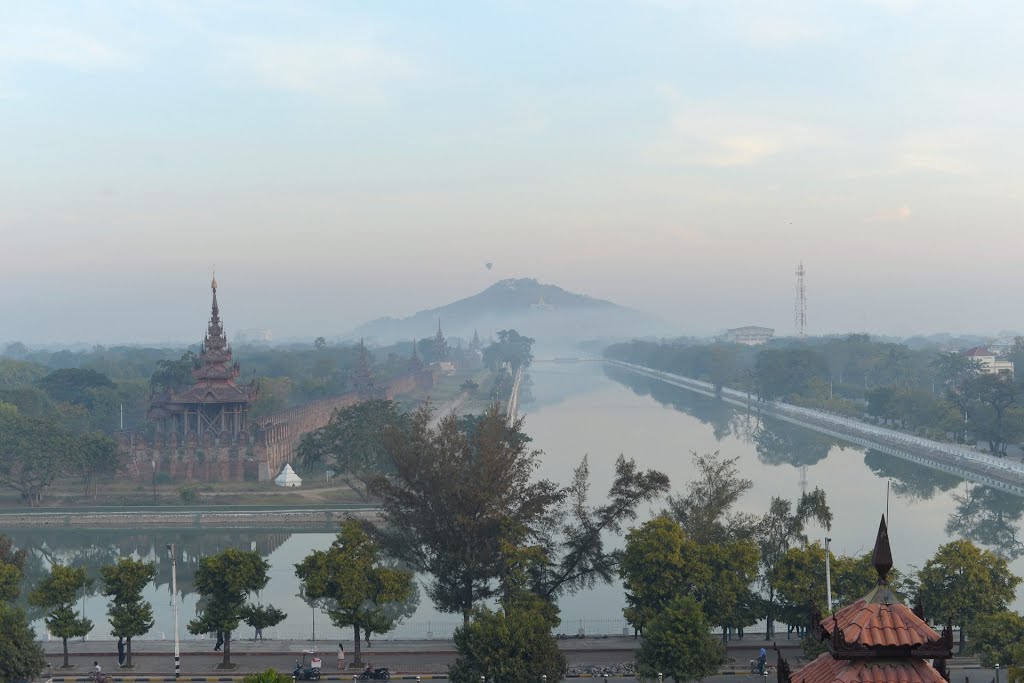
[0, 506, 377, 528]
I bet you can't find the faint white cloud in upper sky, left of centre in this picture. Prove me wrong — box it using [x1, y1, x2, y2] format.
[218, 37, 419, 98]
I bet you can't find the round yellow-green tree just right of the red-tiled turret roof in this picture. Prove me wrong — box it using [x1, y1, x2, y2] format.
[918, 540, 1021, 652]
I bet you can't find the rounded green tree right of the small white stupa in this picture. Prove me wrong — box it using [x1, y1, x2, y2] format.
[299, 399, 409, 500]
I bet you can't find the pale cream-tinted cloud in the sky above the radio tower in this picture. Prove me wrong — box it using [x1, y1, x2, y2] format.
[655, 104, 828, 166]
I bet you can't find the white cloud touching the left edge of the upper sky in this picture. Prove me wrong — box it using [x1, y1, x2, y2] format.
[0, 26, 131, 72]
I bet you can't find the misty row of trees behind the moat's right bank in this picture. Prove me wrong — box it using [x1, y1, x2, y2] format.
[605, 334, 1024, 455]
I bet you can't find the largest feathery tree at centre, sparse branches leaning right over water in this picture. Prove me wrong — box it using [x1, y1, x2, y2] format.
[374, 403, 669, 623]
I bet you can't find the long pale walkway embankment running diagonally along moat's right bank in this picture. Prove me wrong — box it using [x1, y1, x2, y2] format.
[606, 359, 1024, 498]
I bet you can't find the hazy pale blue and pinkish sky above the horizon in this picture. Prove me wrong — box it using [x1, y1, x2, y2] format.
[0, 0, 1024, 342]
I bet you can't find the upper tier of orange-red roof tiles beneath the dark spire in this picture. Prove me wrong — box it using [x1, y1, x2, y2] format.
[821, 586, 939, 647]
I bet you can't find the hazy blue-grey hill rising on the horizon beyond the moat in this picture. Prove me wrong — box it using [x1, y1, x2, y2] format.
[352, 278, 666, 344]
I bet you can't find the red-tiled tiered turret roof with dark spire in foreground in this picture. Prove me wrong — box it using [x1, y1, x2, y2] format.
[776, 515, 953, 683]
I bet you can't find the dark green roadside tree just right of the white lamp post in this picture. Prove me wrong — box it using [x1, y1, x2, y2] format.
[188, 548, 270, 669]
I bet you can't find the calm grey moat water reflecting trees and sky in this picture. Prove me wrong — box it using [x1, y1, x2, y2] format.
[11, 362, 1024, 640]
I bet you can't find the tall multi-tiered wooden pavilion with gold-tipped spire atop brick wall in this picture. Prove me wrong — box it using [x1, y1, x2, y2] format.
[147, 278, 258, 445]
